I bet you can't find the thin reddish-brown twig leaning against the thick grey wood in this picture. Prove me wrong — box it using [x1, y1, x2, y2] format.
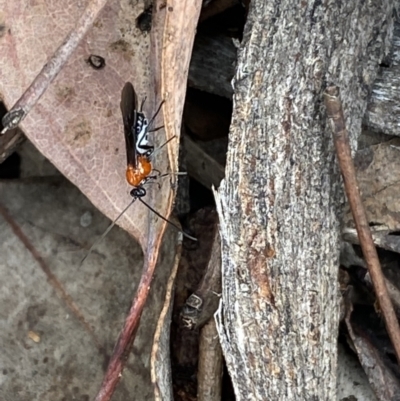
[324, 86, 400, 362]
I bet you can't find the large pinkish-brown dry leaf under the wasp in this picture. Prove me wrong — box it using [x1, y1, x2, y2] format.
[0, 0, 202, 253]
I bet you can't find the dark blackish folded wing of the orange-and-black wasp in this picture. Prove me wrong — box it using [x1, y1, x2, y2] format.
[121, 82, 138, 168]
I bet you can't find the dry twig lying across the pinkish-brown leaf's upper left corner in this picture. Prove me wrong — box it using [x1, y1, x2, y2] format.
[1, 0, 107, 134]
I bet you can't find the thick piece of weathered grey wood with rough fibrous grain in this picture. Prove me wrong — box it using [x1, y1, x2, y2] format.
[217, 0, 394, 400]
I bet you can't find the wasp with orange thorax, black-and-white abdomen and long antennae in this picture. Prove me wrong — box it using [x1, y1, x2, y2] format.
[81, 82, 197, 264]
